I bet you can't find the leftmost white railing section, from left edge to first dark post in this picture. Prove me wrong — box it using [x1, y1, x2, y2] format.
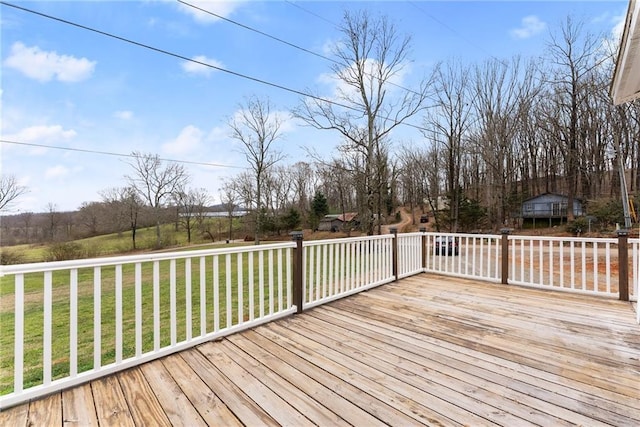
[0, 242, 295, 409]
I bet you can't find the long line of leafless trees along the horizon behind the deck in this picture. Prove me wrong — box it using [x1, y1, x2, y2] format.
[5, 10, 640, 246]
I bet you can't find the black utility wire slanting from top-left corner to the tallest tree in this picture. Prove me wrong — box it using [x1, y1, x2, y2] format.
[0, 1, 427, 131]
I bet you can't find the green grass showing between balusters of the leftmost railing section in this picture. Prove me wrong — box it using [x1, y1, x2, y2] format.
[0, 246, 286, 394]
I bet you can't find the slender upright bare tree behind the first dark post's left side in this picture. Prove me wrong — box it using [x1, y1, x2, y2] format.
[228, 97, 284, 245]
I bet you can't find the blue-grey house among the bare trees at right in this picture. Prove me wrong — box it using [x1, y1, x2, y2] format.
[521, 193, 584, 225]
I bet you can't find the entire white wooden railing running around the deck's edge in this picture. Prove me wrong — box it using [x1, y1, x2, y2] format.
[0, 232, 640, 410]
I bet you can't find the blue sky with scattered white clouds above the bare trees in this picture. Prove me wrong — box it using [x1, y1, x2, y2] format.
[0, 0, 628, 213]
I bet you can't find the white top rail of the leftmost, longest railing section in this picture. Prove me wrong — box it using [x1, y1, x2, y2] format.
[0, 242, 296, 277]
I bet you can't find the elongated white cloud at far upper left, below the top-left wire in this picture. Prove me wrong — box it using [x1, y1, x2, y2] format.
[4, 42, 96, 83]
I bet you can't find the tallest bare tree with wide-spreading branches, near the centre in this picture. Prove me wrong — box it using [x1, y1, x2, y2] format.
[294, 11, 436, 234]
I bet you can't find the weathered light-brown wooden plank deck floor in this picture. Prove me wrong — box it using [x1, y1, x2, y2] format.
[0, 274, 640, 426]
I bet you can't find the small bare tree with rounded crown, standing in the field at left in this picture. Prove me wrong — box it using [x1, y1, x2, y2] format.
[127, 151, 189, 247]
